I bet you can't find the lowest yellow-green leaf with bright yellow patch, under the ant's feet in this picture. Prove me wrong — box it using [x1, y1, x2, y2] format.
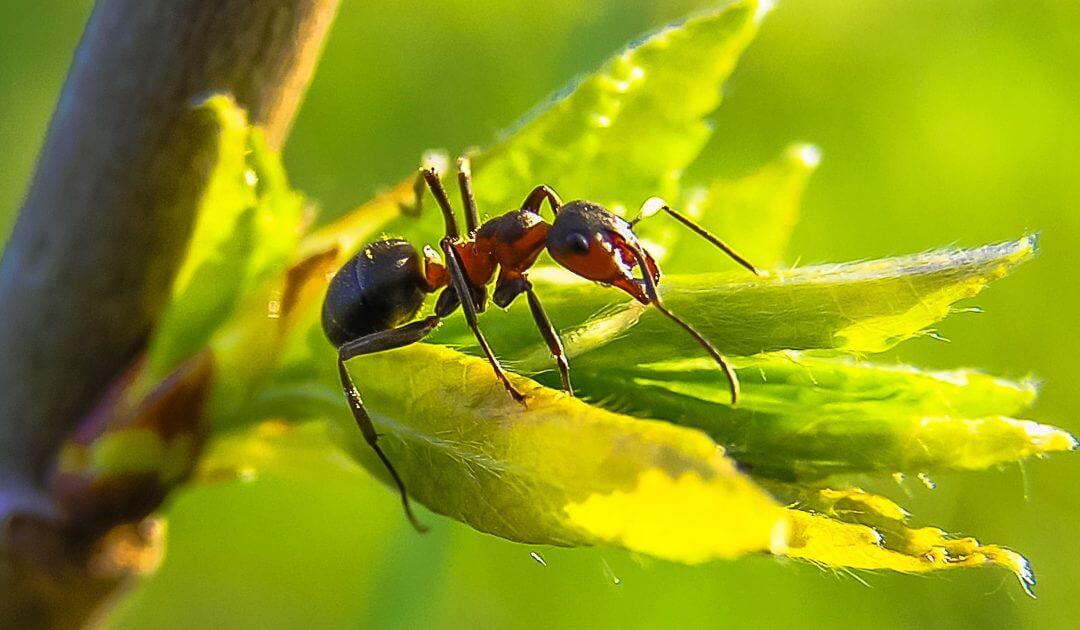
[212, 344, 1034, 589]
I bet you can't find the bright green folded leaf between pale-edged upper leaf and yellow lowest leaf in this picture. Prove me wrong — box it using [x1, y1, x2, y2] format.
[577, 352, 1077, 480]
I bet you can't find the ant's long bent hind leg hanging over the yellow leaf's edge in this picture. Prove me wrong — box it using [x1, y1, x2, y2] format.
[338, 317, 440, 534]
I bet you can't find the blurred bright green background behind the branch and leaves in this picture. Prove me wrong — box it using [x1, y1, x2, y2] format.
[0, 0, 1080, 629]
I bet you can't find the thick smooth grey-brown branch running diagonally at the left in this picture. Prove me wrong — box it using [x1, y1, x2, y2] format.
[0, 0, 338, 625]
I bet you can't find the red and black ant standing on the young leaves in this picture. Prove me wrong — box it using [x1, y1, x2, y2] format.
[322, 158, 757, 532]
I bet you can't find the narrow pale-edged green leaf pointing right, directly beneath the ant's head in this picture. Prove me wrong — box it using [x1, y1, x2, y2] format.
[425, 236, 1037, 363]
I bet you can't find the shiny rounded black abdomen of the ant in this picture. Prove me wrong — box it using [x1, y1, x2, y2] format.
[323, 239, 427, 346]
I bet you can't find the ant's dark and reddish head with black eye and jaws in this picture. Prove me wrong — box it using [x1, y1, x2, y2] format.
[548, 201, 660, 304]
